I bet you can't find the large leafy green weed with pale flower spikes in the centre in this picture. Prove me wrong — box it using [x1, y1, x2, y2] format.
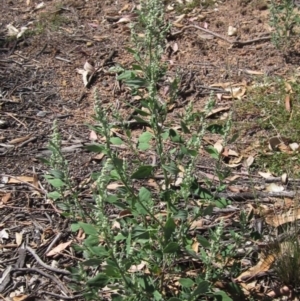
[45, 0, 237, 301]
